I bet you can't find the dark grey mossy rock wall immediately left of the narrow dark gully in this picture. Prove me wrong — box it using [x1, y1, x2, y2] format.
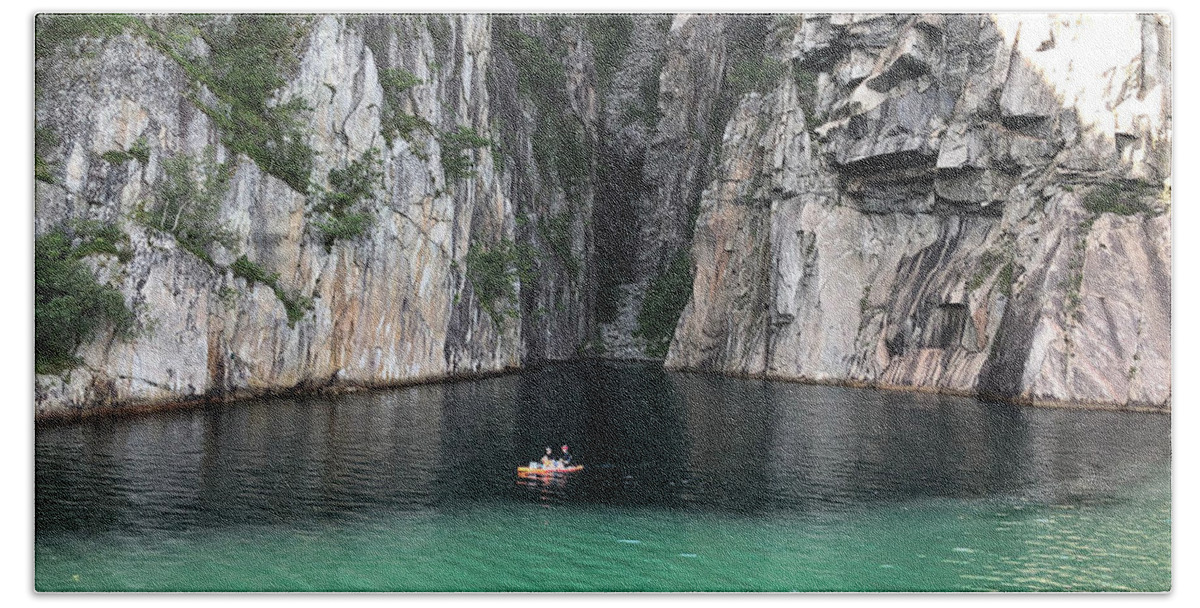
[488, 17, 600, 362]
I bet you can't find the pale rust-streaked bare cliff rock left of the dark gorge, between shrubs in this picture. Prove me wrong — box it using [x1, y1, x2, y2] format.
[36, 16, 521, 413]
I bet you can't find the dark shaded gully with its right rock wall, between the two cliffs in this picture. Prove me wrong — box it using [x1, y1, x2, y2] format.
[596, 14, 720, 359]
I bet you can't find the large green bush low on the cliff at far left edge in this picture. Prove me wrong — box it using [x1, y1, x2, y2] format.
[34, 228, 133, 374]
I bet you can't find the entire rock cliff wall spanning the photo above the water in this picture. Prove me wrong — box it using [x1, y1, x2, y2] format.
[35, 14, 1171, 415]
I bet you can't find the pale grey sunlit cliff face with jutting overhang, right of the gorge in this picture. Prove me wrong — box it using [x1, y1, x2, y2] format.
[666, 14, 1170, 407]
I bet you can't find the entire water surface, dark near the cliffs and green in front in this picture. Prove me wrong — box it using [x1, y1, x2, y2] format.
[35, 363, 1171, 591]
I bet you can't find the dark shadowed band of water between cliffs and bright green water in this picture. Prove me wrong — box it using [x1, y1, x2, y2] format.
[36, 362, 1170, 538]
